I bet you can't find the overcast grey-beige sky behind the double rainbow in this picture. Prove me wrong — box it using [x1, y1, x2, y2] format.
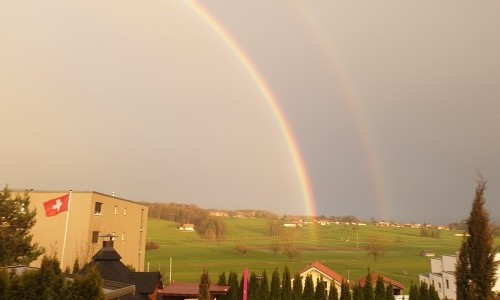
[0, 0, 500, 223]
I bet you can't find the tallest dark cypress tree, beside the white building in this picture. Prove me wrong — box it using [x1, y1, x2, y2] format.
[455, 175, 497, 300]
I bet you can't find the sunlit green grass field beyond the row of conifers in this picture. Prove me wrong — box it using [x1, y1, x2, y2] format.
[146, 217, 500, 287]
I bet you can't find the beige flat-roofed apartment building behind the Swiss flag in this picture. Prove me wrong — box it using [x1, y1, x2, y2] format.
[22, 190, 148, 271]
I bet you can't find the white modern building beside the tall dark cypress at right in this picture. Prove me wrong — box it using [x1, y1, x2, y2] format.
[419, 253, 500, 300]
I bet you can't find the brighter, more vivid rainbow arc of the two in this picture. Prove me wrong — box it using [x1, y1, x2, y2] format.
[185, 1, 316, 216]
